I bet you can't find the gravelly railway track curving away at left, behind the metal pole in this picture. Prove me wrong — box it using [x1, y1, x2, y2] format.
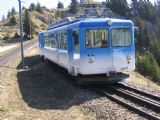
[0, 40, 37, 68]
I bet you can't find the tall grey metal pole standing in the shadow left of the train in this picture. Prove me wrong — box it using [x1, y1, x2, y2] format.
[18, 0, 24, 69]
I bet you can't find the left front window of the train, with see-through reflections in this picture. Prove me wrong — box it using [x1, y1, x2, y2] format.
[86, 29, 109, 48]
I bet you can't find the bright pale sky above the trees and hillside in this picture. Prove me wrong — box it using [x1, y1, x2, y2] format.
[0, 0, 154, 20]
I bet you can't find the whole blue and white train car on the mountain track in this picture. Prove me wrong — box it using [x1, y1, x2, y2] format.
[39, 18, 135, 83]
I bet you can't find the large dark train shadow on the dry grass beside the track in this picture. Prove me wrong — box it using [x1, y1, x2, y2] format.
[17, 56, 97, 109]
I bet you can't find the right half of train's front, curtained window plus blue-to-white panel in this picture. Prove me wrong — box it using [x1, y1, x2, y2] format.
[111, 27, 135, 71]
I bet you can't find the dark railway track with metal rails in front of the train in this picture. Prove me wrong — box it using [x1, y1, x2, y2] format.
[90, 84, 160, 120]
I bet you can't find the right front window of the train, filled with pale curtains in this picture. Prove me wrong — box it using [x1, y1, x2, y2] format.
[112, 28, 131, 47]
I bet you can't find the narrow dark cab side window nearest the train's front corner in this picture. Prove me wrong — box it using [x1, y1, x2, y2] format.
[73, 31, 80, 52]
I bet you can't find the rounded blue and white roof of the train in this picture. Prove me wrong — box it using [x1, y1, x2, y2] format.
[41, 18, 133, 30]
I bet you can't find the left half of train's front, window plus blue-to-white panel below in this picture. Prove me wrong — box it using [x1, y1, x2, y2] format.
[84, 28, 112, 74]
